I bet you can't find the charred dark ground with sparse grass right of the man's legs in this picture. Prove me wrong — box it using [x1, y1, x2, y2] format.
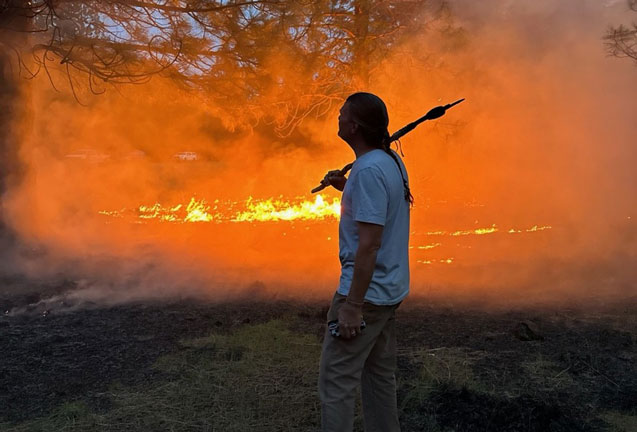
[398, 302, 637, 432]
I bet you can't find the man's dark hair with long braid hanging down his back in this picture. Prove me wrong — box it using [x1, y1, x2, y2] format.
[345, 92, 414, 206]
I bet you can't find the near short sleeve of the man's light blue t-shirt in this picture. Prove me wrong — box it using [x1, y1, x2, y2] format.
[352, 167, 389, 226]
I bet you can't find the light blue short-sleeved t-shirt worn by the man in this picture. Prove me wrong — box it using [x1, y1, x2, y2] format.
[338, 149, 409, 305]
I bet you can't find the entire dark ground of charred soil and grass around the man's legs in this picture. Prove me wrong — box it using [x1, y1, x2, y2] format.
[0, 286, 637, 432]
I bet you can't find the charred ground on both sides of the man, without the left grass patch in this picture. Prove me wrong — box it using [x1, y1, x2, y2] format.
[0, 287, 637, 432]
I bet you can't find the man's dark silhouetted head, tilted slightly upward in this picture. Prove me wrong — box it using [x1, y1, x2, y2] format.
[338, 92, 389, 148]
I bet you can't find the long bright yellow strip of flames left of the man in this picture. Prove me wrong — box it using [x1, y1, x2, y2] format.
[99, 195, 341, 223]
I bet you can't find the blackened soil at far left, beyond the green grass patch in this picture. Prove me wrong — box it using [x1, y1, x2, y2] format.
[0, 290, 304, 422]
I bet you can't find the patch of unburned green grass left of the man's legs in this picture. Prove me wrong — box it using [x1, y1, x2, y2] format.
[3, 320, 320, 432]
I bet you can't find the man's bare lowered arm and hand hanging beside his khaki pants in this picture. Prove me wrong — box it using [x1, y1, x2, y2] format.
[338, 222, 383, 339]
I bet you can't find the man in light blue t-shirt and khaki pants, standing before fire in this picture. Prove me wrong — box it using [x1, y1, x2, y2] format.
[319, 93, 412, 432]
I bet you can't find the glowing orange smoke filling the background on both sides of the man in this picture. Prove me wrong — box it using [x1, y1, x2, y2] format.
[4, 0, 637, 310]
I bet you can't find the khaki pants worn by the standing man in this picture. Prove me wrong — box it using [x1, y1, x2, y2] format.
[319, 293, 400, 432]
